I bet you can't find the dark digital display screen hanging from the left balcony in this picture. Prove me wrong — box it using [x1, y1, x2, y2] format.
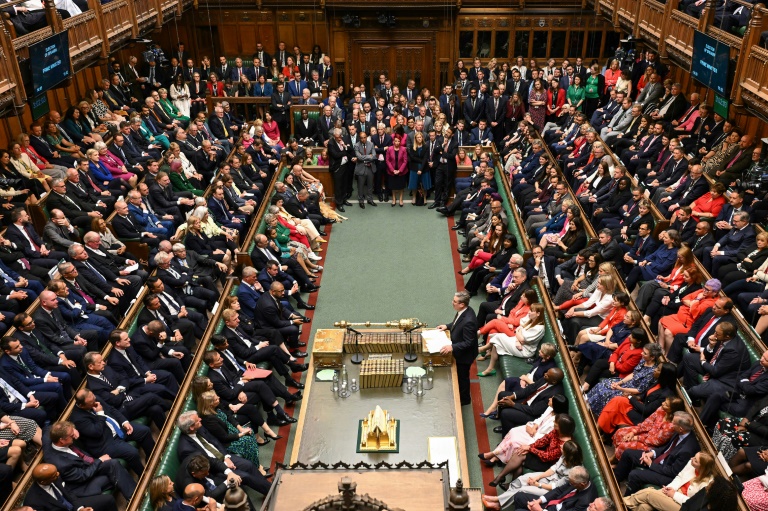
[29, 31, 72, 96]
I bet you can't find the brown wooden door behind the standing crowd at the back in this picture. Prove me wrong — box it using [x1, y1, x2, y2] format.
[351, 38, 433, 90]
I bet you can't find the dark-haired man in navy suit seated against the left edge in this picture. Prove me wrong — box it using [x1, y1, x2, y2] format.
[0, 337, 72, 409]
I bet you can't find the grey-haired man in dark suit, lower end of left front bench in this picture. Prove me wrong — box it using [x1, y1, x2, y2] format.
[176, 411, 270, 495]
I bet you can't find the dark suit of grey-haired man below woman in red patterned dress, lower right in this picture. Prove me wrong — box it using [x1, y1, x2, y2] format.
[613, 432, 699, 495]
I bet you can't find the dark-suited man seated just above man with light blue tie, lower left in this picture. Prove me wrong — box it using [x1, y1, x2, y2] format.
[83, 351, 171, 428]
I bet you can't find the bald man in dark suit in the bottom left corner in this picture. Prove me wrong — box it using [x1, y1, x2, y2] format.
[24, 463, 117, 511]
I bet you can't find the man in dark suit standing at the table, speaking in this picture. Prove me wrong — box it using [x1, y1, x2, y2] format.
[437, 291, 477, 406]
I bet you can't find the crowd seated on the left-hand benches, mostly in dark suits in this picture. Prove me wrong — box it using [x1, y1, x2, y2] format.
[0, 46, 364, 509]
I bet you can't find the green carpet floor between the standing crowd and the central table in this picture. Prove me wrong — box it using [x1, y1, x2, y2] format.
[278, 202, 486, 486]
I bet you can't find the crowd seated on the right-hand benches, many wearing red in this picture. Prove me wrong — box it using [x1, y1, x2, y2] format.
[426, 52, 768, 509]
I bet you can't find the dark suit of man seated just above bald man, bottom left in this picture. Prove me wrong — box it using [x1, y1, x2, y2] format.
[43, 446, 136, 500]
